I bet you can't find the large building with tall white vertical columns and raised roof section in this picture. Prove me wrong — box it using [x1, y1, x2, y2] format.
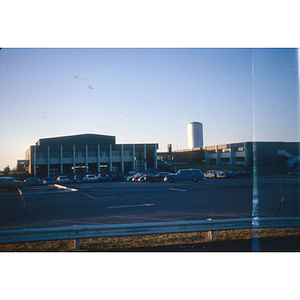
[25, 134, 158, 177]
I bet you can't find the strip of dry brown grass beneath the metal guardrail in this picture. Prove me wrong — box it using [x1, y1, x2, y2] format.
[0, 227, 300, 252]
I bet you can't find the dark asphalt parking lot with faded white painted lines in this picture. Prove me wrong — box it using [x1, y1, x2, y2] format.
[0, 176, 300, 230]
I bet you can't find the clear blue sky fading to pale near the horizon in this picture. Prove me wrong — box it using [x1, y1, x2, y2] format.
[0, 48, 300, 170]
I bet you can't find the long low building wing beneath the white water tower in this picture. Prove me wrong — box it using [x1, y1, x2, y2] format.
[157, 142, 300, 167]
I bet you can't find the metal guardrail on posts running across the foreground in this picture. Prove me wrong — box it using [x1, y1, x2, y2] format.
[0, 217, 300, 249]
